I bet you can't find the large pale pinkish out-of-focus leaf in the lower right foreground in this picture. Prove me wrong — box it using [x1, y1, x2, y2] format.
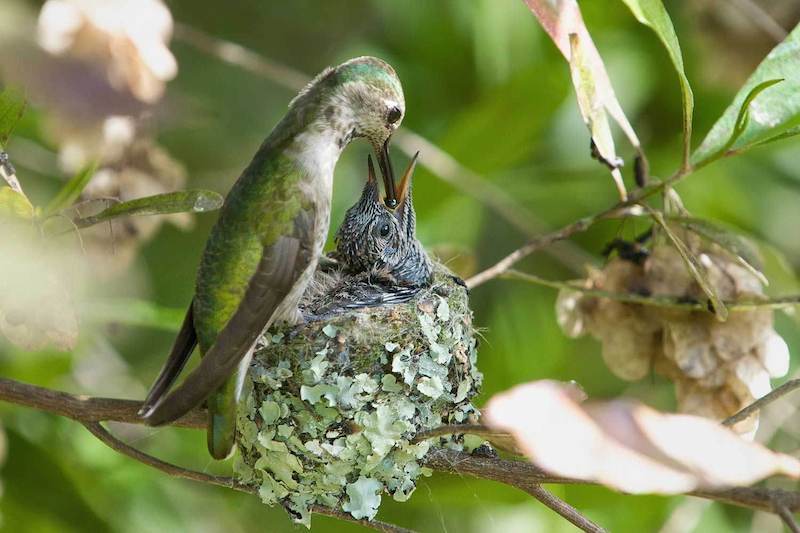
[483, 381, 800, 494]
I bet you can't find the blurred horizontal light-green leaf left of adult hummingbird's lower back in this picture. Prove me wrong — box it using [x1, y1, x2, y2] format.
[82, 298, 186, 331]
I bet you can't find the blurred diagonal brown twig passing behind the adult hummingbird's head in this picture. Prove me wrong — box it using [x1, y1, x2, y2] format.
[175, 23, 591, 272]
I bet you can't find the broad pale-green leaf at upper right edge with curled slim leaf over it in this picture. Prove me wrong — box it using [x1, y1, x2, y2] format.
[692, 25, 800, 166]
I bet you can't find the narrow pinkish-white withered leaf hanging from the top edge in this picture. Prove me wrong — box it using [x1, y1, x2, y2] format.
[525, 0, 642, 194]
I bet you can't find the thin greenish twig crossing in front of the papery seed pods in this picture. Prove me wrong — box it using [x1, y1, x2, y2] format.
[506, 269, 800, 311]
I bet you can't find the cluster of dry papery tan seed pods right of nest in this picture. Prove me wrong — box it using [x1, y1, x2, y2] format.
[556, 244, 789, 437]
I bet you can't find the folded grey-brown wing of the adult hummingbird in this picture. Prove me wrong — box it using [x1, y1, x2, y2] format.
[145, 208, 316, 426]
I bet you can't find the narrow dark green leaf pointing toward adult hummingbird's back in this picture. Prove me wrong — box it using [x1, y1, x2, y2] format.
[75, 189, 223, 228]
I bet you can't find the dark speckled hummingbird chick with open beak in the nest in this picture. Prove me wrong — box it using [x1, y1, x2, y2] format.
[301, 154, 432, 320]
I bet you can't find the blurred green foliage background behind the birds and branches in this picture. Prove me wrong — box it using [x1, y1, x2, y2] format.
[0, 0, 800, 532]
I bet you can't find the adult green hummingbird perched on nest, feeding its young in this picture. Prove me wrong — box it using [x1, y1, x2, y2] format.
[140, 57, 405, 459]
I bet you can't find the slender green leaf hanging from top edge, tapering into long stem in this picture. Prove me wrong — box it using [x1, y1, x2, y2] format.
[623, 0, 694, 165]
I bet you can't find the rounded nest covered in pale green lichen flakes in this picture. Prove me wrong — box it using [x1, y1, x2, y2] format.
[231, 265, 482, 525]
